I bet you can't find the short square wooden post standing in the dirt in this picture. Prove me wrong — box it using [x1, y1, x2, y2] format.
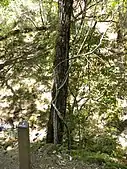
[18, 121, 30, 169]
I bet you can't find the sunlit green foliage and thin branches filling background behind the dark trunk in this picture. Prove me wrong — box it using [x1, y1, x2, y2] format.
[0, 0, 127, 168]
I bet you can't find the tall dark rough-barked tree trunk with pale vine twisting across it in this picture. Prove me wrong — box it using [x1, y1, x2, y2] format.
[46, 0, 73, 144]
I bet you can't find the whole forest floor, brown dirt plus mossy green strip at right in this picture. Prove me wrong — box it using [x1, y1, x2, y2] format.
[0, 131, 127, 169]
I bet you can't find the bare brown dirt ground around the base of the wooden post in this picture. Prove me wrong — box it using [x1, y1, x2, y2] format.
[0, 143, 104, 169]
